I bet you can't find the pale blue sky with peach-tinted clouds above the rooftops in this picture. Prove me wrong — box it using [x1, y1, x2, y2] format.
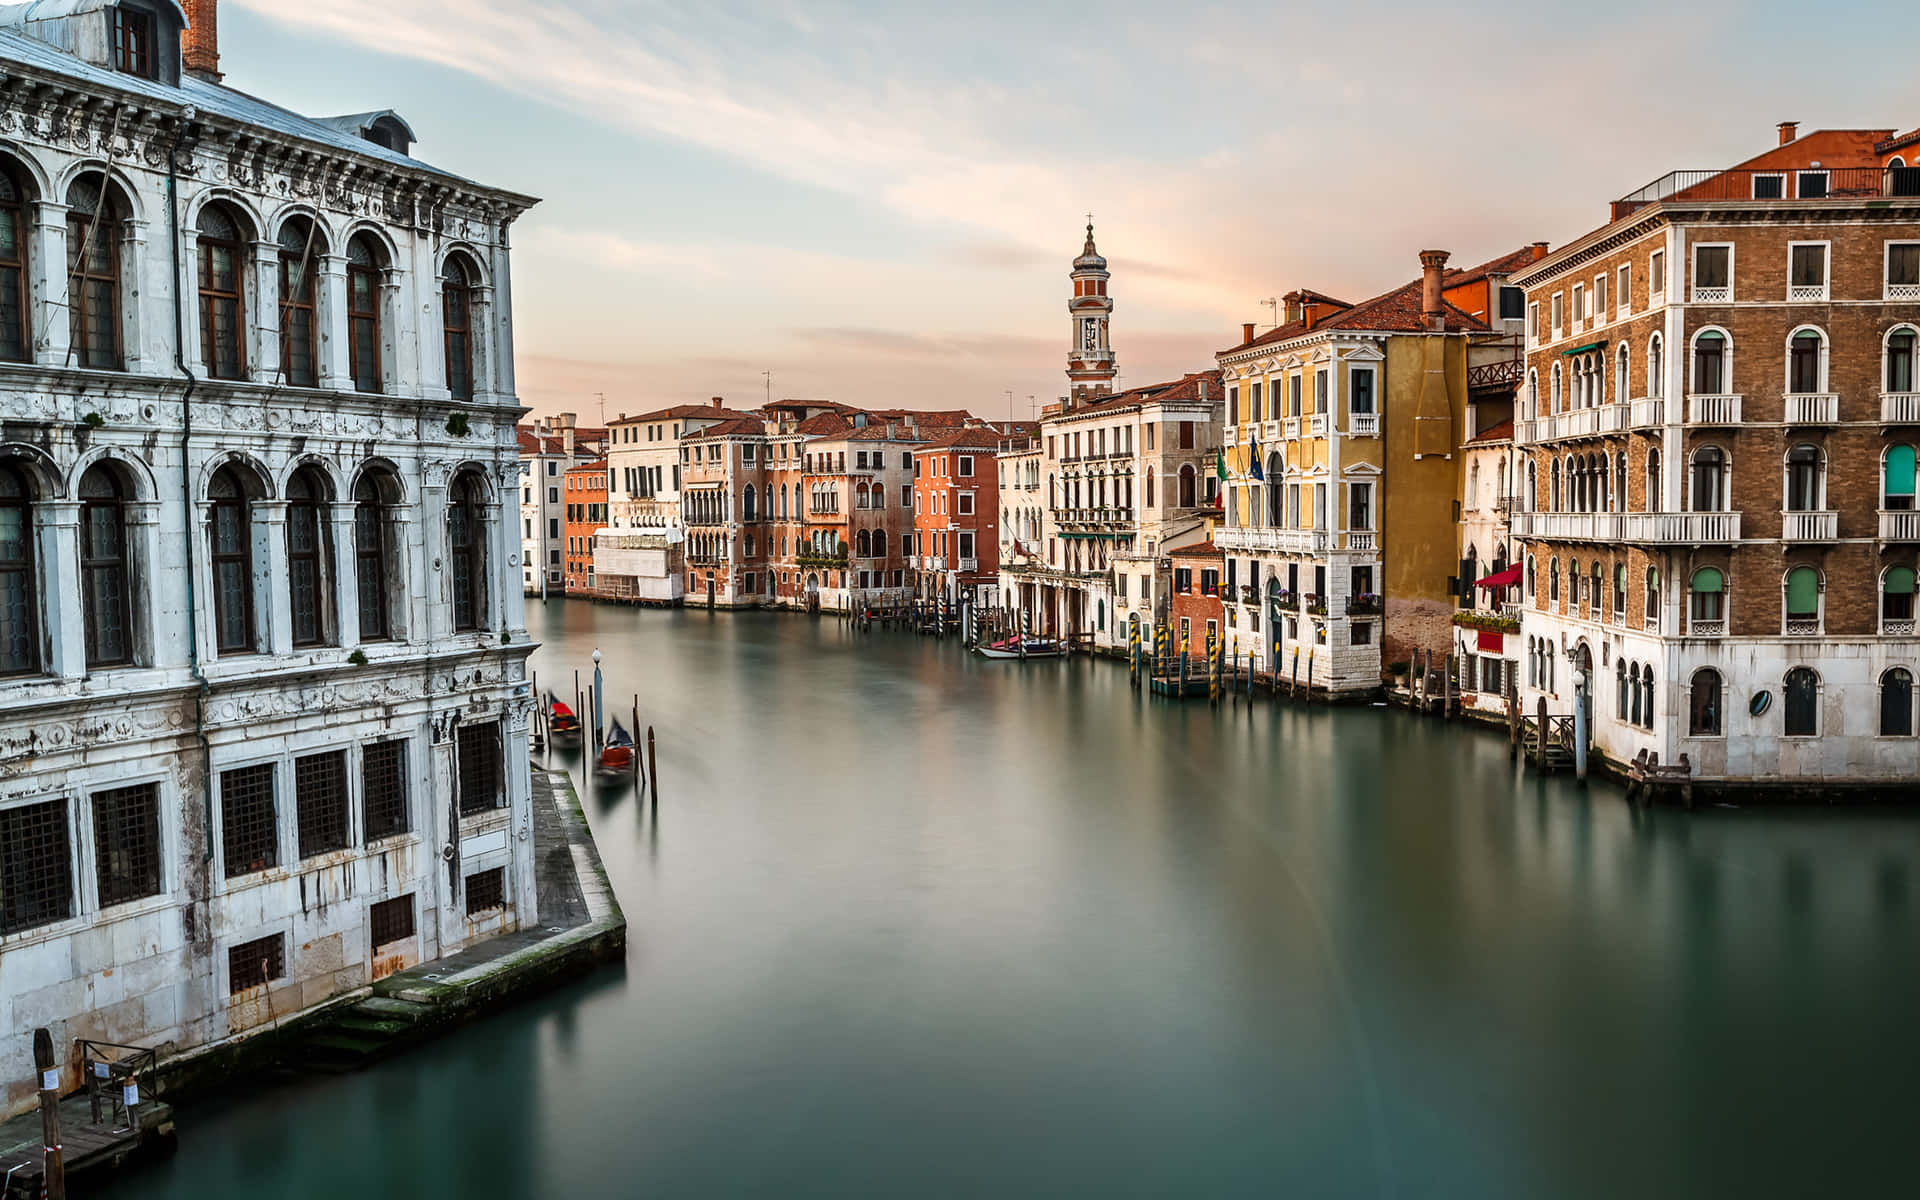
[221, 0, 1920, 422]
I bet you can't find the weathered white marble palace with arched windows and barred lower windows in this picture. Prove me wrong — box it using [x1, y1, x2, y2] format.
[0, 0, 534, 1110]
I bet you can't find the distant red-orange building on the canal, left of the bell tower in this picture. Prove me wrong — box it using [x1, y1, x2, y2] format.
[910, 426, 1006, 609]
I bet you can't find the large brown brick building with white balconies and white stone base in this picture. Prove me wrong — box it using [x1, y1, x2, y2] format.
[1513, 125, 1920, 785]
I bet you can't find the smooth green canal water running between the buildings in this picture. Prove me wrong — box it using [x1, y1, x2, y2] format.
[109, 601, 1920, 1200]
